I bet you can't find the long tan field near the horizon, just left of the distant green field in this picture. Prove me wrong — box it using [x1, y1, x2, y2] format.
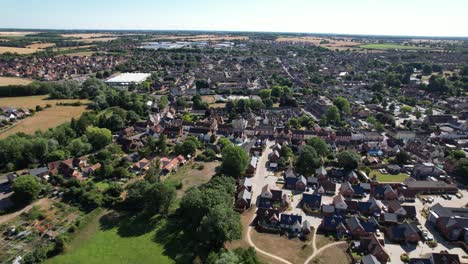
[276, 37, 362, 50]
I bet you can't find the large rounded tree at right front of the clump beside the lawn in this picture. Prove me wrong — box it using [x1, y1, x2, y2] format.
[198, 205, 242, 248]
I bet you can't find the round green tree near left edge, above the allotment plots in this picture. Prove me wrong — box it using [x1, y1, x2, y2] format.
[12, 175, 42, 204]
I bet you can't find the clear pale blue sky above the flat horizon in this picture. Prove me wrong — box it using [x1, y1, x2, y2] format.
[0, 0, 468, 37]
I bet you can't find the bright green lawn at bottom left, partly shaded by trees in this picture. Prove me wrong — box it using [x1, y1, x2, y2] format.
[45, 210, 175, 264]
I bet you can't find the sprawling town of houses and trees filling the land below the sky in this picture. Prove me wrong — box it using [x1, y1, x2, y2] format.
[0, 14, 468, 264]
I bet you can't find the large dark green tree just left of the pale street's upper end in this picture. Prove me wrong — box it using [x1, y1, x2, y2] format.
[221, 144, 249, 177]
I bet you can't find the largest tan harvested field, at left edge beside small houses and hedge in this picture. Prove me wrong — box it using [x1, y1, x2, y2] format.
[0, 95, 89, 139]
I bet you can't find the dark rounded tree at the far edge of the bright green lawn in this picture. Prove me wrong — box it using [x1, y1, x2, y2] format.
[145, 182, 176, 215]
